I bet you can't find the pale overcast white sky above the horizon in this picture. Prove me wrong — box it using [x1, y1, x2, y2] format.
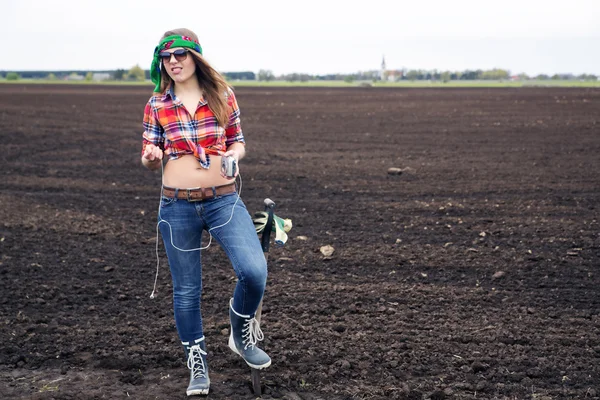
[0, 0, 600, 75]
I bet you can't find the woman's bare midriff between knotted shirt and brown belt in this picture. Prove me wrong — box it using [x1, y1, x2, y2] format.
[163, 155, 234, 189]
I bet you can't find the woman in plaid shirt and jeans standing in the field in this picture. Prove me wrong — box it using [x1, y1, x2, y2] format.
[142, 29, 271, 396]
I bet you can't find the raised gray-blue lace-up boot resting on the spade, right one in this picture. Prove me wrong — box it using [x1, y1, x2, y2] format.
[229, 299, 271, 369]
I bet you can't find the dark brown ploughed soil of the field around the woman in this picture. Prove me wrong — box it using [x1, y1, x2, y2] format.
[0, 84, 600, 400]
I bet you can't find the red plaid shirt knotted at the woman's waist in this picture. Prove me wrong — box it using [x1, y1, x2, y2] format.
[142, 86, 245, 168]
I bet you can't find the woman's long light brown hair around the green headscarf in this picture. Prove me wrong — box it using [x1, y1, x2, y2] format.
[160, 28, 232, 128]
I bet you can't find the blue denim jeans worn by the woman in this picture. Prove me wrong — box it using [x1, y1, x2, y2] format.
[159, 193, 267, 342]
